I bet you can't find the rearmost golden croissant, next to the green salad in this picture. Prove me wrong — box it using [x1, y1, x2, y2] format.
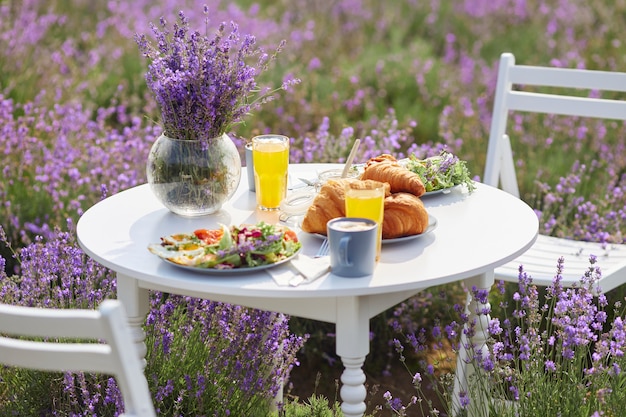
[361, 160, 426, 197]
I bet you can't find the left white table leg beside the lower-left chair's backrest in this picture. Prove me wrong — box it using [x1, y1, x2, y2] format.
[117, 273, 150, 368]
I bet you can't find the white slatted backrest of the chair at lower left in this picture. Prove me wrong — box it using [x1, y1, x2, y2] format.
[0, 300, 156, 417]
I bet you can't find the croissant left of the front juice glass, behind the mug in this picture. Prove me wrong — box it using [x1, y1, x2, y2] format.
[300, 179, 390, 235]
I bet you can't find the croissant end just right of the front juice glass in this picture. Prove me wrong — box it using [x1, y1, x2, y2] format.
[383, 193, 428, 239]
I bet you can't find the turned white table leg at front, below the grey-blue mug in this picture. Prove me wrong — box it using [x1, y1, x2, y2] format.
[336, 297, 369, 417]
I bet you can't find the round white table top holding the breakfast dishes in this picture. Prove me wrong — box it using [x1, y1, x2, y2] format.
[77, 164, 538, 298]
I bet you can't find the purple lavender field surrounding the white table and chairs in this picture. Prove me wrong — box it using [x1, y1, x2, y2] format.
[0, 0, 626, 416]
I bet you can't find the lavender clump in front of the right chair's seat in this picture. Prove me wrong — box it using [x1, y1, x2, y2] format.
[458, 256, 626, 415]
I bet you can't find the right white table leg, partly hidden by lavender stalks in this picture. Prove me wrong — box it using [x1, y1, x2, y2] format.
[452, 272, 494, 417]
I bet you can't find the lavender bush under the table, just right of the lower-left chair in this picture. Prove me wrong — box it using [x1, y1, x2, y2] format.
[146, 293, 306, 415]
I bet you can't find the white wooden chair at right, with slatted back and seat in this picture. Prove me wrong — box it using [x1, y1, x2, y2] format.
[483, 53, 626, 292]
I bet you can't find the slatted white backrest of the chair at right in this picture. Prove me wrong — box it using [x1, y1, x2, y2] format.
[483, 53, 626, 197]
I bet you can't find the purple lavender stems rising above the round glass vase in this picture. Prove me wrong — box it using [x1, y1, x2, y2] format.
[135, 6, 297, 140]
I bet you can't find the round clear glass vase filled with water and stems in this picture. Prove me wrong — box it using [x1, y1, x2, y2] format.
[146, 134, 241, 217]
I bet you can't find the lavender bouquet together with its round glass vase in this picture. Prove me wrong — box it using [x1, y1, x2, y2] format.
[135, 6, 291, 216]
